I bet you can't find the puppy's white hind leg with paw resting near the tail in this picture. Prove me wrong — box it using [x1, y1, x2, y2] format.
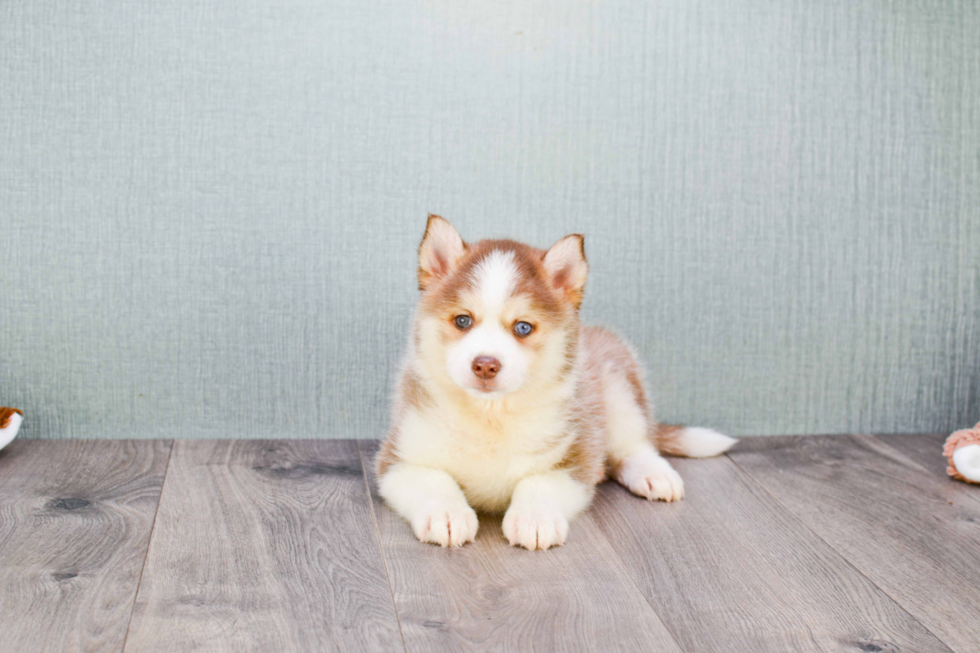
[603, 375, 684, 501]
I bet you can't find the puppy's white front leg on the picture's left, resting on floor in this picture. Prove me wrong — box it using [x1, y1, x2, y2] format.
[378, 463, 479, 546]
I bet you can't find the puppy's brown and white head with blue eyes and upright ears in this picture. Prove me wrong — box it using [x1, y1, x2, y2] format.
[416, 215, 588, 400]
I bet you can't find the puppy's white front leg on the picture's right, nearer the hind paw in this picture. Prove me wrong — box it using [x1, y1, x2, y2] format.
[503, 470, 594, 551]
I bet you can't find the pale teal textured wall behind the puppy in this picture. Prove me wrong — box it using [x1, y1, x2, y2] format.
[0, 0, 980, 438]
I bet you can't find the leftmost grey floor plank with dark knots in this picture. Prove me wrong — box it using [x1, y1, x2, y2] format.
[0, 439, 171, 651]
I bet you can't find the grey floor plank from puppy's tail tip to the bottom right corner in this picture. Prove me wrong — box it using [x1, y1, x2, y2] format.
[731, 436, 980, 653]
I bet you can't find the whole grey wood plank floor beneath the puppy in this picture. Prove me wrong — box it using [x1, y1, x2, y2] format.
[0, 435, 980, 653]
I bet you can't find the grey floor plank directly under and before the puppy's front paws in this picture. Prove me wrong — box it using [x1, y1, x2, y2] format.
[361, 441, 680, 652]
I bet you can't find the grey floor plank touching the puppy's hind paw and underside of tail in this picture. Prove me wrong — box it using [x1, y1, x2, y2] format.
[593, 450, 948, 653]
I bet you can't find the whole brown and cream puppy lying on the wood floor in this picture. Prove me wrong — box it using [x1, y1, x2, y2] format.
[376, 215, 735, 550]
